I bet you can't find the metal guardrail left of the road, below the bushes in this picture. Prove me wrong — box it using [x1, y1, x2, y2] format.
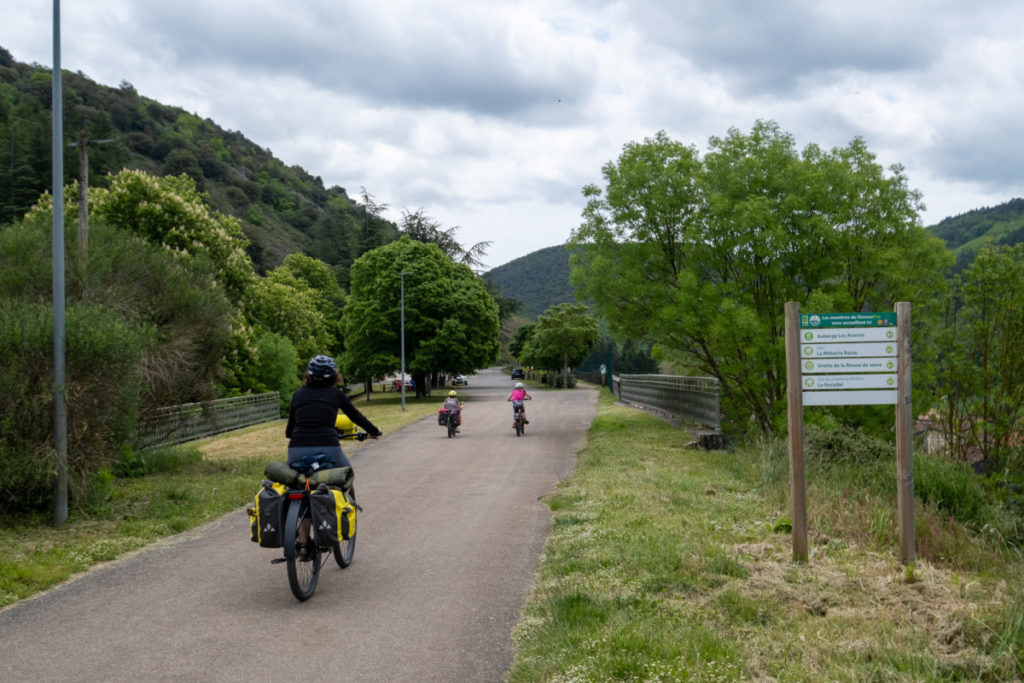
[135, 391, 281, 449]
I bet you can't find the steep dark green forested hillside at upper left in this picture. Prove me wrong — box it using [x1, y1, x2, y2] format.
[0, 47, 398, 283]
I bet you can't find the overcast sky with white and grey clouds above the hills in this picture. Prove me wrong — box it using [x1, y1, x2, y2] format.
[0, 0, 1024, 266]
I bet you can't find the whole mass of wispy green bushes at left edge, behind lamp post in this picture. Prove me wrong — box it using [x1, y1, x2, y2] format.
[0, 214, 232, 513]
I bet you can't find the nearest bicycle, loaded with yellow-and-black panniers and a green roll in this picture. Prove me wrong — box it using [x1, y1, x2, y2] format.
[248, 433, 367, 601]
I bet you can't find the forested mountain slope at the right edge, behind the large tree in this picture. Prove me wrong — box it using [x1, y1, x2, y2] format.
[929, 199, 1024, 272]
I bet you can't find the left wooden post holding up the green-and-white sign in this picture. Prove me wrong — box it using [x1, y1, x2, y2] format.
[785, 301, 807, 562]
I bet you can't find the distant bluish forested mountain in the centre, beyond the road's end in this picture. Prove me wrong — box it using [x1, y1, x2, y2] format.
[483, 245, 575, 321]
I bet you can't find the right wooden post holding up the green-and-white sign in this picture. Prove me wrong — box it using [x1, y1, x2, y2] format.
[896, 301, 916, 564]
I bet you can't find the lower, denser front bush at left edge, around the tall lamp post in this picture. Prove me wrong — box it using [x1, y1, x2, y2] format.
[0, 301, 148, 512]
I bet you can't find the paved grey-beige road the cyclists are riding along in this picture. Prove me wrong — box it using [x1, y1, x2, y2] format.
[0, 370, 597, 683]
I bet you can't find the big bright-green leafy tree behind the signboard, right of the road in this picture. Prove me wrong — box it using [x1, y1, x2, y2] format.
[568, 121, 949, 431]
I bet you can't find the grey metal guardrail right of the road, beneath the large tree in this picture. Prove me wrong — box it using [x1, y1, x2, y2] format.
[611, 375, 722, 432]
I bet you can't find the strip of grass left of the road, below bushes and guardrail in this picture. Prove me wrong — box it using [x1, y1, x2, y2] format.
[0, 393, 441, 608]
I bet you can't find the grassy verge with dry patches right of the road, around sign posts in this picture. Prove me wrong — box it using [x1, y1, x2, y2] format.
[508, 392, 1024, 682]
